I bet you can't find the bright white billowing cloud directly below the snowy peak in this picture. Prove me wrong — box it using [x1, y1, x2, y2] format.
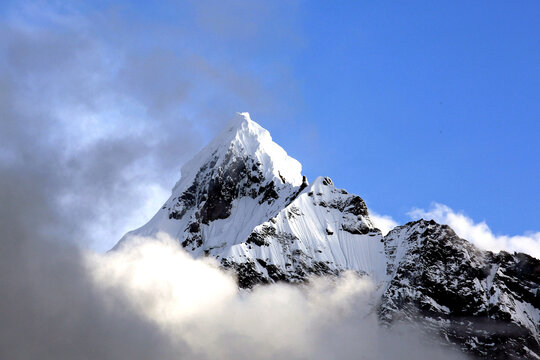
[85, 234, 461, 359]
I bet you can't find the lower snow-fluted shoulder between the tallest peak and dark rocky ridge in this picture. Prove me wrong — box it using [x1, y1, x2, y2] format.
[222, 177, 386, 286]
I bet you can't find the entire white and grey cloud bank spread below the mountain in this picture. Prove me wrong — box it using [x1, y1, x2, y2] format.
[0, 228, 461, 360]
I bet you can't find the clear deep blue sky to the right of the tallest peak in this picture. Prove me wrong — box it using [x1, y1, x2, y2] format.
[282, 2, 540, 233]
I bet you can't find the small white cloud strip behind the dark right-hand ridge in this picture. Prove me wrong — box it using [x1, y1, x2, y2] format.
[408, 203, 540, 259]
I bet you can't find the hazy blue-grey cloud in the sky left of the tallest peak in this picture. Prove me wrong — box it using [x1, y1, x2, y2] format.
[0, 2, 302, 249]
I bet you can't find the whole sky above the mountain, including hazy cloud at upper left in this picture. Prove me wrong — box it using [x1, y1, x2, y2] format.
[0, 0, 540, 248]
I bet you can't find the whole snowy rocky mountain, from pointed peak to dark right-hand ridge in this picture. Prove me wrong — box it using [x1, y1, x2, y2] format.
[115, 113, 540, 359]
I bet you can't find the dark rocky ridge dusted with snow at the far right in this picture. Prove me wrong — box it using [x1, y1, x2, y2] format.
[379, 220, 540, 359]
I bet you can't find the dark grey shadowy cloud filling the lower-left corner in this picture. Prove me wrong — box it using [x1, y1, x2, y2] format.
[0, 160, 181, 359]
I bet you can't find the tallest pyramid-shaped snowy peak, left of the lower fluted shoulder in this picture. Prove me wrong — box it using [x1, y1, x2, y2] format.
[115, 113, 308, 256]
